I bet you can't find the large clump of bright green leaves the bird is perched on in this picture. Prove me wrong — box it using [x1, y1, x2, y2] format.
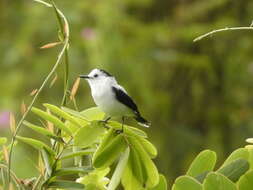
[1, 104, 166, 190]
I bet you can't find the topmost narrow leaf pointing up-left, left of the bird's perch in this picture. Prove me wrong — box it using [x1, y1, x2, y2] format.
[43, 104, 82, 127]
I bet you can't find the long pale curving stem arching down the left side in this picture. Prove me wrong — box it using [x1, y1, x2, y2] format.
[7, 0, 69, 182]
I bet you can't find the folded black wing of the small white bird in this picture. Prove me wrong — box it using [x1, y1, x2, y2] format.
[112, 86, 139, 114]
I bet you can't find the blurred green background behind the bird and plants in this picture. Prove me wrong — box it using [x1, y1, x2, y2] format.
[0, 0, 253, 187]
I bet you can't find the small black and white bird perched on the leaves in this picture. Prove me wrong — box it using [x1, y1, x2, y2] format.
[80, 69, 150, 127]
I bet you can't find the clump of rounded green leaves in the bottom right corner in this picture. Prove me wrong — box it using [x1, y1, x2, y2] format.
[172, 145, 253, 190]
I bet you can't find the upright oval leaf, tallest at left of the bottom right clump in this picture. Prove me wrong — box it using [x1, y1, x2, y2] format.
[186, 150, 216, 177]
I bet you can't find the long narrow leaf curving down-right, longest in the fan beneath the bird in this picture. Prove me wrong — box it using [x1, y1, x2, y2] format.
[128, 137, 159, 188]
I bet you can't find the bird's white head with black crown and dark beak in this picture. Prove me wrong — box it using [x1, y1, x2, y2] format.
[80, 69, 113, 84]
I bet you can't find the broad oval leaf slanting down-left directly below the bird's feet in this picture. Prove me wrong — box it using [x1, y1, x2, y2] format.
[93, 134, 127, 168]
